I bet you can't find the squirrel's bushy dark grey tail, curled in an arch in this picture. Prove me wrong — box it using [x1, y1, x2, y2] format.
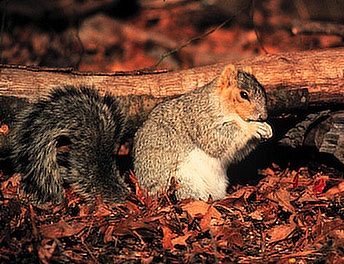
[12, 86, 128, 203]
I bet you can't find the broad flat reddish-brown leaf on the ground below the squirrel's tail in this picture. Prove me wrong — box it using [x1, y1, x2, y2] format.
[39, 220, 87, 239]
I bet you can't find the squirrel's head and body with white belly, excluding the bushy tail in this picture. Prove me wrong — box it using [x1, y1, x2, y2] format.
[133, 65, 273, 200]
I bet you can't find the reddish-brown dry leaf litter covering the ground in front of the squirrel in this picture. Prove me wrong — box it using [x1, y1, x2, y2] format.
[0, 165, 344, 263]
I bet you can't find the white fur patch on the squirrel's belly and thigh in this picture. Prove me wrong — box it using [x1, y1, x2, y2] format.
[177, 148, 228, 200]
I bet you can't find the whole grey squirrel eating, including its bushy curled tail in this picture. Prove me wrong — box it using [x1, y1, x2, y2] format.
[12, 65, 272, 203]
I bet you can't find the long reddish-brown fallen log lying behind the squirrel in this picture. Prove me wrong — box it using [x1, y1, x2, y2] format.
[0, 48, 344, 162]
